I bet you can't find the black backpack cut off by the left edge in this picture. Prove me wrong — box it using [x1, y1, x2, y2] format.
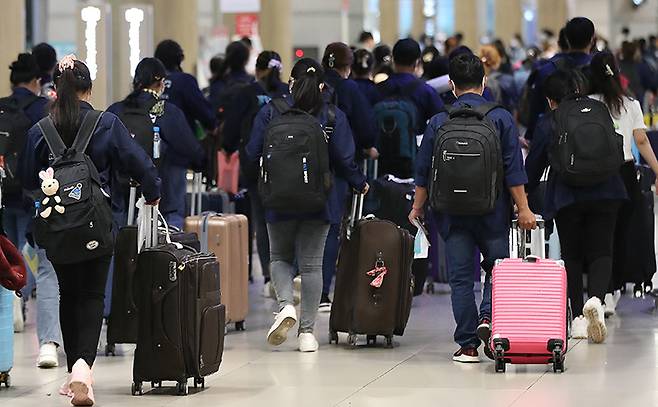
[0, 95, 39, 193]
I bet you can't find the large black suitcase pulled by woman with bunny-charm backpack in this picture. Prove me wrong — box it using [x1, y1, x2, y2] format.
[132, 207, 226, 395]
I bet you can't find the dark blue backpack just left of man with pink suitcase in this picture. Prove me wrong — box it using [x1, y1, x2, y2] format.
[374, 80, 423, 178]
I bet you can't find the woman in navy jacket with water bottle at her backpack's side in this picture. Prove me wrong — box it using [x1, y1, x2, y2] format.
[108, 58, 205, 228]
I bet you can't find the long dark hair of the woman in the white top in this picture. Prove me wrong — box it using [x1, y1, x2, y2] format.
[590, 52, 627, 116]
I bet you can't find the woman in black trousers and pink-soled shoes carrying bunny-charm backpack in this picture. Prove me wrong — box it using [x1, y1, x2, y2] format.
[19, 55, 160, 406]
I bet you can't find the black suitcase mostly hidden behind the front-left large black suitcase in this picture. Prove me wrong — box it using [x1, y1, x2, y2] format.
[105, 185, 201, 356]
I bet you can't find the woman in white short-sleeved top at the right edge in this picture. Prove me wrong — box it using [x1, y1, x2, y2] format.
[590, 52, 658, 315]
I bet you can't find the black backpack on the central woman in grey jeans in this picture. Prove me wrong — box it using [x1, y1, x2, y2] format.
[258, 99, 336, 213]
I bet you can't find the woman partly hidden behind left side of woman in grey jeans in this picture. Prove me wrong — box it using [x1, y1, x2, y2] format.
[222, 51, 288, 296]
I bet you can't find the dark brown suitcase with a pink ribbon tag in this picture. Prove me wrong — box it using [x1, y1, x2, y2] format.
[329, 195, 414, 347]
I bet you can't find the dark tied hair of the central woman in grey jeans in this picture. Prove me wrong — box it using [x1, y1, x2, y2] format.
[290, 58, 324, 115]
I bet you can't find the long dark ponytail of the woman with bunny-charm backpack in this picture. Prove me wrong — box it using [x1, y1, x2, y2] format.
[50, 60, 92, 146]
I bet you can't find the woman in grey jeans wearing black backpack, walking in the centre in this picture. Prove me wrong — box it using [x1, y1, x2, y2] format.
[247, 58, 368, 352]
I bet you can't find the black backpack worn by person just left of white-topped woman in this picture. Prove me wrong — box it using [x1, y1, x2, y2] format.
[549, 96, 624, 187]
